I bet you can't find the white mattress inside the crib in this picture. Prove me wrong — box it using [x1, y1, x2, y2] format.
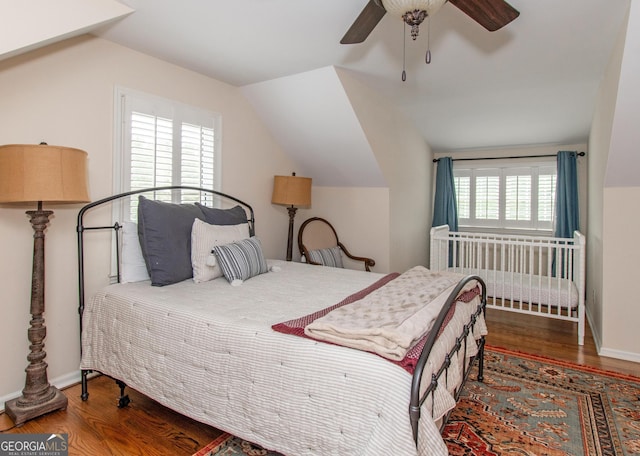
[448, 268, 578, 309]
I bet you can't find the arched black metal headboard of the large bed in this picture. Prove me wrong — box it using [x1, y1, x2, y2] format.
[76, 185, 255, 335]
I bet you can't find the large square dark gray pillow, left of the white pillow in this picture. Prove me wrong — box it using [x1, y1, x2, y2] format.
[138, 196, 205, 286]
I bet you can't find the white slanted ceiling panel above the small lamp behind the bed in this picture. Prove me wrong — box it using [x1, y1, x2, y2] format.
[242, 66, 387, 187]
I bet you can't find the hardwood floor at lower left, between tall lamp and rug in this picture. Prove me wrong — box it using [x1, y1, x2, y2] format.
[0, 376, 220, 456]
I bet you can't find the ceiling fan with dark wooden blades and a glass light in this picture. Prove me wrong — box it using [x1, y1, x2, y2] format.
[340, 0, 520, 44]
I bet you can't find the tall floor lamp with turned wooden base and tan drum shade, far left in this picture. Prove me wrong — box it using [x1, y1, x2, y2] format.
[0, 144, 89, 425]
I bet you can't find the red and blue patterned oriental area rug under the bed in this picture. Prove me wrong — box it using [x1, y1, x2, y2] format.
[194, 347, 640, 456]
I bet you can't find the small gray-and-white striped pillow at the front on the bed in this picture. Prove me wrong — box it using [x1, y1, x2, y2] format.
[212, 236, 269, 283]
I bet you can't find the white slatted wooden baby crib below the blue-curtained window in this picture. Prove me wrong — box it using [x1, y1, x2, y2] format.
[430, 225, 586, 345]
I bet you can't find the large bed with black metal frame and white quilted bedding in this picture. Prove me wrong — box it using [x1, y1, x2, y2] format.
[77, 187, 486, 455]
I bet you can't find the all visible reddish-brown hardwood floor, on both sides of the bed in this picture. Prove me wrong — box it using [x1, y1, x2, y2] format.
[0, 310, 640, 456]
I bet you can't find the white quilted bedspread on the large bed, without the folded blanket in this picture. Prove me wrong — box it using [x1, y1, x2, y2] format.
[81, 261, 486, 456]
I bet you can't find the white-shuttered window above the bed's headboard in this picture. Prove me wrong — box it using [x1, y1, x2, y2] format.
[114, 88, 220, 220]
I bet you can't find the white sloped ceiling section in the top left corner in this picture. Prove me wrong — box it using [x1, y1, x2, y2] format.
[0, 0, 133, 60]
